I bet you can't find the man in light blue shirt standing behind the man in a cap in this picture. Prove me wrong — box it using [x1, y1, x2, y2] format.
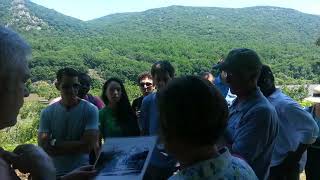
[258, 65, 319, 180]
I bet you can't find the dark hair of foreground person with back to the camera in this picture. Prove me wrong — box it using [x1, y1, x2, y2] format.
[157, 76, 228, 146]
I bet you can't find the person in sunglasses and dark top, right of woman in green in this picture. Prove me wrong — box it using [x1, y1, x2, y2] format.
[132, 72, 154, 132]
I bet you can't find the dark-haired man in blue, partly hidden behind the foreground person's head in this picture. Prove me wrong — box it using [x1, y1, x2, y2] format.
[140, 61, 176, 180]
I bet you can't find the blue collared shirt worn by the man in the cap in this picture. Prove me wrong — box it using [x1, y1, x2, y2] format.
[225, 88, 279, 180]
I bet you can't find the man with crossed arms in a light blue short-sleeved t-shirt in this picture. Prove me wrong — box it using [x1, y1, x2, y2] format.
[38, 68, 99, 176]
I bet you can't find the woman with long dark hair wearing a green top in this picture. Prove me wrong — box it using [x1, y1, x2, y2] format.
[99, 78, 139, 139]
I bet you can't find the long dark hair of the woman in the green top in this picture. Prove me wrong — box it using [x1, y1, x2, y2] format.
[101, 77, 134, 122]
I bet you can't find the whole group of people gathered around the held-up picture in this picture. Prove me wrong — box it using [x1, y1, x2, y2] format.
[0, 27, 320, 180]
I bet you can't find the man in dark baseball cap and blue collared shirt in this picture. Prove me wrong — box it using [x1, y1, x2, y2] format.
[220, 48, 278, 180]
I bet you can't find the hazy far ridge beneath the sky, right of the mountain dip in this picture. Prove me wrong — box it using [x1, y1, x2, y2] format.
[88, 6, 320, 43]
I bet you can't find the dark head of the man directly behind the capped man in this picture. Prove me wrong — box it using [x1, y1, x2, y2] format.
[258, 65, 276, 97]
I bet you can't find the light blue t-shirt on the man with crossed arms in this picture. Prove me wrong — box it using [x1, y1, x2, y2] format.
[39, 100, 98, 175]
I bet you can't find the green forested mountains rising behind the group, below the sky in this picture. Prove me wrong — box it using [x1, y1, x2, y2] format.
[0, 0, 320, 83]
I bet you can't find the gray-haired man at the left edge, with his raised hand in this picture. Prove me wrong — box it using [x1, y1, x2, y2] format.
[0, 26, 93, 180]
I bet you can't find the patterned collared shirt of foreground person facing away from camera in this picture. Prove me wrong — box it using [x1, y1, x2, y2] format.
[169, 148, 258, 180]
